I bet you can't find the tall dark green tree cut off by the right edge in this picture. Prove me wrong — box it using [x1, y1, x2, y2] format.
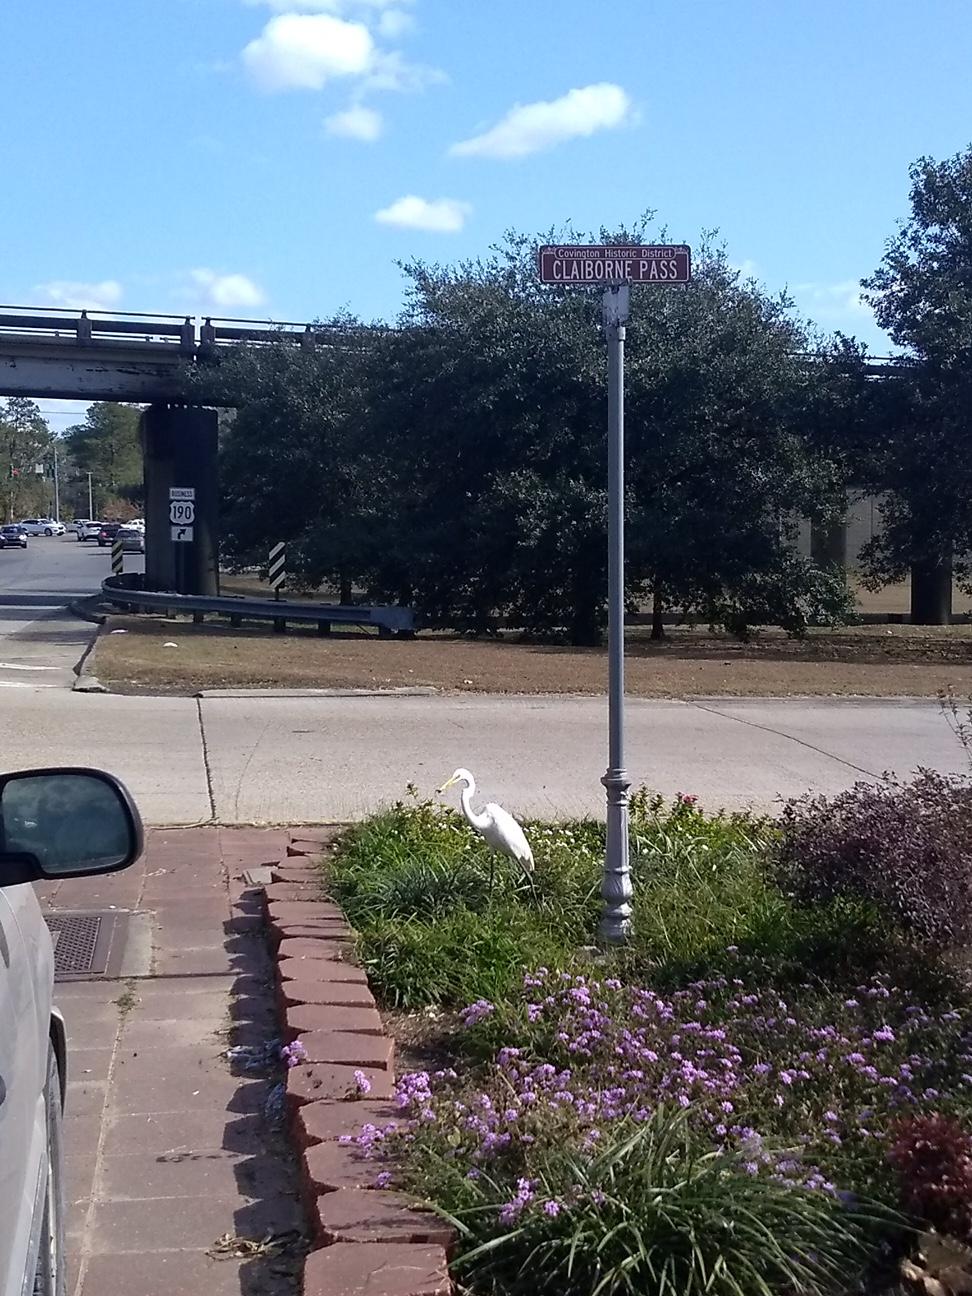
[862, 146, 972, 623]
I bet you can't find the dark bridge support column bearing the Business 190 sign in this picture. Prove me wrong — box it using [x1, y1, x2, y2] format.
[141, 404, 219, 595]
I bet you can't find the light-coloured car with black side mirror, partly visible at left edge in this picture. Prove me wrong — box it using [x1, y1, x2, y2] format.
[0, 769, 143, 1296]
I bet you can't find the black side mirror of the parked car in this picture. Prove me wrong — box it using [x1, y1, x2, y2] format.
[0, 769, 144, 886]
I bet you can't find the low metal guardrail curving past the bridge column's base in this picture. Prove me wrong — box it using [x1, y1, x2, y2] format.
[101, 572, 415, 639]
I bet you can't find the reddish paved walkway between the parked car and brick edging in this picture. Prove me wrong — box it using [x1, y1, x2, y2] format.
[41, 828, 303, 1296]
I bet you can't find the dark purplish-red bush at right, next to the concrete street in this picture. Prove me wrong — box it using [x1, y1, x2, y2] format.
[779, 770, 972, 946]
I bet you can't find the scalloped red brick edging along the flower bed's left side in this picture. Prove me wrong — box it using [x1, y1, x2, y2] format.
[264, 828, 452, 1296]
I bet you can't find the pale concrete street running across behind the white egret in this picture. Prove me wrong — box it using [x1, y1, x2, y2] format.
[0, 688, 968, 824]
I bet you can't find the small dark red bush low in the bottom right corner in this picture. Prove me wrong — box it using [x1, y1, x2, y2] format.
[888, 1116, 972, 1243]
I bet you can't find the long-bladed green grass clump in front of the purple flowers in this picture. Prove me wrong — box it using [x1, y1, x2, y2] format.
[437, 1109, 881, 1296]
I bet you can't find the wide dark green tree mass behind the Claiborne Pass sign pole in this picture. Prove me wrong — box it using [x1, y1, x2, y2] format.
[206, 226, 846, 643]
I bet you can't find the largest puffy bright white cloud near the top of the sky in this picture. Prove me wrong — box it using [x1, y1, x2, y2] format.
[242, 13, 375, 91]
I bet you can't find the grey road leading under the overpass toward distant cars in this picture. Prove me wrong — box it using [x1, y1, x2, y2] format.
[0, 535, 143, 689]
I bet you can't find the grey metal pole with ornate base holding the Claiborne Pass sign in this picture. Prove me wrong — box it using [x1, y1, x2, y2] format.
[600, 284, 632, 945]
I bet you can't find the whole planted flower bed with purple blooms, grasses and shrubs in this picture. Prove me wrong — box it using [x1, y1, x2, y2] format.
[334, 772, 972, 1296]
